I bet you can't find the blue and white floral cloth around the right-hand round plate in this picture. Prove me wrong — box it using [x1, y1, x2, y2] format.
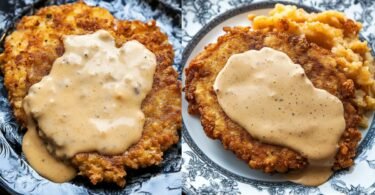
[182, 0, 375, 194]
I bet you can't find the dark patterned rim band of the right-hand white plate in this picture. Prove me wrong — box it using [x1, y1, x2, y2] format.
[181, 0, 375, 193]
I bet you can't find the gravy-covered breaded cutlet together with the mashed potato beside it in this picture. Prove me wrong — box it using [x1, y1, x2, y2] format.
[185, 4, 374, 186]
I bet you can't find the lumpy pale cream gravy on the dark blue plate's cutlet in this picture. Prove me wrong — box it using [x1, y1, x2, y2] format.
[23, 30, 156, 182]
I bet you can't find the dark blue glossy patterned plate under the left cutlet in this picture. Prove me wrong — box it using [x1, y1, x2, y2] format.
[0, 0, 182, 195]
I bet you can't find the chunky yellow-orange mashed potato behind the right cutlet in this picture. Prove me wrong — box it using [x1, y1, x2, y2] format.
[249, 4, 375, 110]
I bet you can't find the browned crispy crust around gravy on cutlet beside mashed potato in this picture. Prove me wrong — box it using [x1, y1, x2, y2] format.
[185, 27, 361, 173]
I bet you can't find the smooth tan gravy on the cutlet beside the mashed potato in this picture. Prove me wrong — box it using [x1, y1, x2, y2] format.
[214, 48, 345, 185]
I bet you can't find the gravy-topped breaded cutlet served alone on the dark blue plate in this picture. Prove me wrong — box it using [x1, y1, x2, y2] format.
[0, 2, 181, 186]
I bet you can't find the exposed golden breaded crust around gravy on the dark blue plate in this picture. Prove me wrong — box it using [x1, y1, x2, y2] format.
[0, 3, 181, 186]
